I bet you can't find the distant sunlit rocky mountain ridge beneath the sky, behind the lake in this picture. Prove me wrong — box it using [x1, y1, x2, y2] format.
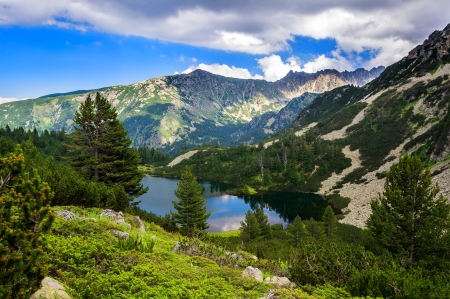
[0, 67, 383, 152]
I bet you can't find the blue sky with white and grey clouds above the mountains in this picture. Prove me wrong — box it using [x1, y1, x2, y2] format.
[0, 0, 450, 103]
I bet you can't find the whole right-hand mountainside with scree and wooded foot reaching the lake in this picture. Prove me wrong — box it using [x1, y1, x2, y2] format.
[160, 25, 450, 227]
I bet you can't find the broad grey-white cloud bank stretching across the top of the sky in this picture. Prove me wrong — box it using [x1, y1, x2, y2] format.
[0, 0, 450, 69]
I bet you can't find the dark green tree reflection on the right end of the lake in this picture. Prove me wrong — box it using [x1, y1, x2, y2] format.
[239, 193, 328, 222]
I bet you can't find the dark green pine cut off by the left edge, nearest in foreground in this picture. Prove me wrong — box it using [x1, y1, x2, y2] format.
[0, 146, 54, 298]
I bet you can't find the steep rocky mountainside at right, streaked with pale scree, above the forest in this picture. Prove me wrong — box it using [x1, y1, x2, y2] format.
[291, 24, 450, 227]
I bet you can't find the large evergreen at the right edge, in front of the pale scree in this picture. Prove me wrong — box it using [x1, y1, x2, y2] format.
[367, 154, 450, 268]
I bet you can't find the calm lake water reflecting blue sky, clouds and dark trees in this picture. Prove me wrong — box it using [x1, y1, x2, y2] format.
[139, 176, 327, 232]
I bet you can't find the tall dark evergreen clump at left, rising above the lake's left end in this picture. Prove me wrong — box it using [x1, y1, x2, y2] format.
[69, 93, 148, 202]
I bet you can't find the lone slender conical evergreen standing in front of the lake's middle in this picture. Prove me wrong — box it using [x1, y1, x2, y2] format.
[172, 166, 211, 237]
